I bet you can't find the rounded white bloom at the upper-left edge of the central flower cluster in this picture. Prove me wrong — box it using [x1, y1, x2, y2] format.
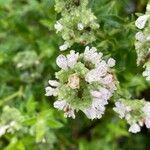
[56, 55, 68, 70]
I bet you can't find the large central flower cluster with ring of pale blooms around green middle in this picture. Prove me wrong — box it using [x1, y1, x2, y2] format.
[46, 46, 117, 119]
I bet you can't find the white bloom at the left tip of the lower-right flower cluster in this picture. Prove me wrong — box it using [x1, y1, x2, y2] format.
[113, 102, 131, 118]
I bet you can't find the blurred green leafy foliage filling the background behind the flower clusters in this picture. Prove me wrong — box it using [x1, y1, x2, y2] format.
[0, 0, 150, 150]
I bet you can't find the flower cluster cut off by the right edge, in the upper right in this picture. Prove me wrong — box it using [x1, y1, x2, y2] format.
[135, 4, 150, 80]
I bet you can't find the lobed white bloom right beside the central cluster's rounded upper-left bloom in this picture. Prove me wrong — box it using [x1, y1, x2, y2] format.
[67, 50, 79, 68]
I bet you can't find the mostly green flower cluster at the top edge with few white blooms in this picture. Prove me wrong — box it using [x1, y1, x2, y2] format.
[54, 0, 99, 51]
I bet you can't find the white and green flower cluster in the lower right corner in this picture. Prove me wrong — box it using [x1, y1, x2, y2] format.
[114, 99, 150, 133]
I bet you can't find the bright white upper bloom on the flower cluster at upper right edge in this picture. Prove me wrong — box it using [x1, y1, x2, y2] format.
[135, 15, 150, 29]
